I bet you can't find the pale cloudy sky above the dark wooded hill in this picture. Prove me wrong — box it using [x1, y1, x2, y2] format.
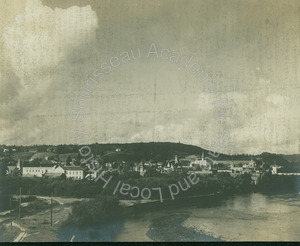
[0, 0, 300, 154]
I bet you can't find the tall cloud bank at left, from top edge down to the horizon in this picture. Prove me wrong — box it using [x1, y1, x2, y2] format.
[0, 0, 98, 144]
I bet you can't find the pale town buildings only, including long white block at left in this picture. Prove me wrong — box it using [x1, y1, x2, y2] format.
[7, 152, 261, 180]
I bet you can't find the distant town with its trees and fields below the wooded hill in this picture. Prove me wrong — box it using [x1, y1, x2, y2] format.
[0, 145, 300, 184]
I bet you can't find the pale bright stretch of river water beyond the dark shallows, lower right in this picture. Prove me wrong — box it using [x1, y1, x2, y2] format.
[184, 193, 300, 241]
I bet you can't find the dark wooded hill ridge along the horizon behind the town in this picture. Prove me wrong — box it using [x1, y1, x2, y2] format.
[2, 142, 300, 166]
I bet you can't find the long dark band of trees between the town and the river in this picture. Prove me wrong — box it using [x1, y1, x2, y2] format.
[0, 171, 300, 202]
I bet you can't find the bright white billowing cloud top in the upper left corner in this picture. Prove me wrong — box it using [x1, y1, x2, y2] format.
[3, 0, 97, 84]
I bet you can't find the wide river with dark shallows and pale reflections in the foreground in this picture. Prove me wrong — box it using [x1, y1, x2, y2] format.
[61, 193, 300, 241]
